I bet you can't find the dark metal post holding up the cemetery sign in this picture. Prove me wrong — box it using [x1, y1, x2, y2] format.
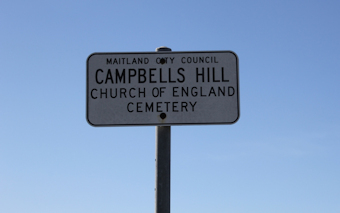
[155, 47, 171, 213]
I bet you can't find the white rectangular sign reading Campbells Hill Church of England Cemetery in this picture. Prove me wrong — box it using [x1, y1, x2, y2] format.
[86, 51, 240, 126]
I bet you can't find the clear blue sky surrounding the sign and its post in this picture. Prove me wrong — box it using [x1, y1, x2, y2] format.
[0, 0, 340, 213]
